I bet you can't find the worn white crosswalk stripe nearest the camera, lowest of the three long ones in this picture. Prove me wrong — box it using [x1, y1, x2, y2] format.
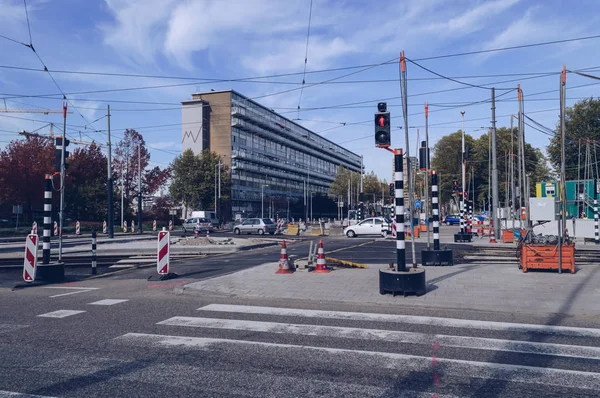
[115, 333, 600, 390]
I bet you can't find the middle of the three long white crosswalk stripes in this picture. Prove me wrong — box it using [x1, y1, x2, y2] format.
[157, 316, 600, 359]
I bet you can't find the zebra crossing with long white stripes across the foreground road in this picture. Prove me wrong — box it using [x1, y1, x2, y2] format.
[114, 304, 600, 397]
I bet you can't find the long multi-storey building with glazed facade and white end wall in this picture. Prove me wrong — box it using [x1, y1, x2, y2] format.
[182, 90, 362, 217]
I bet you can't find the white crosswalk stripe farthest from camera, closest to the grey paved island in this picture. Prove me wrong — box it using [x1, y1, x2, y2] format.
[198, 304, 600, 337]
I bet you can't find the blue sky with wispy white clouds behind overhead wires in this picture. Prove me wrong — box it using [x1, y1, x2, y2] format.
[0, 0, 600, 180]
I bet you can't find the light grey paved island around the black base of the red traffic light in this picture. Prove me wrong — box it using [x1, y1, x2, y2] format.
[176, 261, 600, 316]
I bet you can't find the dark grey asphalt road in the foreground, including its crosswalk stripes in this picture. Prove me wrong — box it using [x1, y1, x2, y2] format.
[0, 276, 600, 398]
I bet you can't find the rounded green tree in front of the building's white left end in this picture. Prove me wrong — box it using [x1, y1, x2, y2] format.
[169, 149, 231, 210]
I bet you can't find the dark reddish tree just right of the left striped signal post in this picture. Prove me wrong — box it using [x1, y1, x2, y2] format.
[65, 143, 108, 221]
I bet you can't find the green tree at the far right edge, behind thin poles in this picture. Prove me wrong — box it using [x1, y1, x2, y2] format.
[547, 98, 600, 180]
